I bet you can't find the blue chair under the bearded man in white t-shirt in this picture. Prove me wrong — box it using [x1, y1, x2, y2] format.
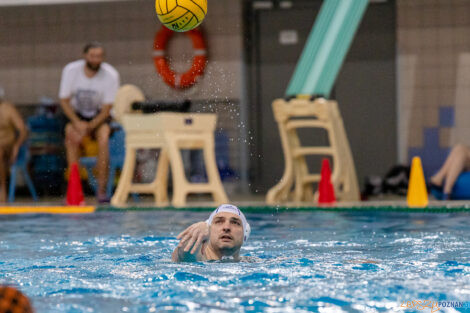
[80, 125, 126, 197]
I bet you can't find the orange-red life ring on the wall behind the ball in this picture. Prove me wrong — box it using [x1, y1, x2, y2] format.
[153, 26, 207, 89]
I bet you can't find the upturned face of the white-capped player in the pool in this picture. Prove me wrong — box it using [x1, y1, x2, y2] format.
[210, 212, 243, 255]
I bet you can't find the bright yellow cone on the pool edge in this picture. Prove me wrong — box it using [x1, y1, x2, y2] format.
[406, 157, 428, 208]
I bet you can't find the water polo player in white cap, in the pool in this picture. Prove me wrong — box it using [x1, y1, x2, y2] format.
[171, 204, 251, 262]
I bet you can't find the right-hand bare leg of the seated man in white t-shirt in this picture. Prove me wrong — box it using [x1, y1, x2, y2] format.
[95, 123, 111, 199]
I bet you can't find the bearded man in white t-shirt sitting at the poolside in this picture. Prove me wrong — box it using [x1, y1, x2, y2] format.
[59, 42, 119, 202]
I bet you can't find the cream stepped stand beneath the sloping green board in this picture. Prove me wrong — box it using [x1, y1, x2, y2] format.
[266, 99, 359, 204]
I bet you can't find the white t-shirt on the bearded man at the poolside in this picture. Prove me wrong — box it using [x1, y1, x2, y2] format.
[59, 60, 120, 118]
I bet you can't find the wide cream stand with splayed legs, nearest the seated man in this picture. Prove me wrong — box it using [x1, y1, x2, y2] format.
[111, 86, 228, 207]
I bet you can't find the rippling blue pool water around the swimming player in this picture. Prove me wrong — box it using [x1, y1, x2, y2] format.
[0, 211, 470, 313]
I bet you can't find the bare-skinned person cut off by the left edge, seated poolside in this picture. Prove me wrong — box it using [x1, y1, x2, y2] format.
[0, 87, 27, 203]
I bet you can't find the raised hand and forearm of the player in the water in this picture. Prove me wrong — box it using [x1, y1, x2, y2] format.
[171, 222, 209, 262]
